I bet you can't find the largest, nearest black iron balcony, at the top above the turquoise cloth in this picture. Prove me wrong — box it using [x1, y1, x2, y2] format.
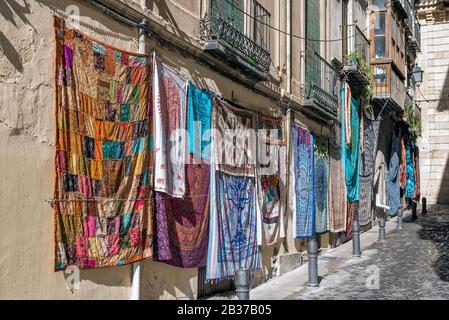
[200, 0, 271, 80]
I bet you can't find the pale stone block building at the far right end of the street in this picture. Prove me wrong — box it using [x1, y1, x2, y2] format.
[417, 0, 449, 204]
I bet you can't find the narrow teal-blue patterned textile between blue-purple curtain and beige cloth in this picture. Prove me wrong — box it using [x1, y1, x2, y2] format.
[314, 137, 330, 233]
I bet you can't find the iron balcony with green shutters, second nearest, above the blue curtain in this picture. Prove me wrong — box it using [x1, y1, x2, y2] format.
[300, 50, 338, 118]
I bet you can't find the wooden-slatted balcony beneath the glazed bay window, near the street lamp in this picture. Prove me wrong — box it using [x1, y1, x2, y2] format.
[373, 63, 406, 111]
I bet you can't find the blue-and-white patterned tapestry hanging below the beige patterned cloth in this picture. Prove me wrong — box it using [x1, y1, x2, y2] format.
[207, 171, 261, 279]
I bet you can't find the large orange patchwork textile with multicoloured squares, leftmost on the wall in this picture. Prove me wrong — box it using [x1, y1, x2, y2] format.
[53, 18, 153, 270]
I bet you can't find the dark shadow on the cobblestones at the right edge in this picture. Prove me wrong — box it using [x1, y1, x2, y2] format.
[418, 208, 449, 282]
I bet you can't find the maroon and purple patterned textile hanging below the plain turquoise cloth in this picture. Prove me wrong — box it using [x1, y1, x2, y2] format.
[154, 158, 210, 268]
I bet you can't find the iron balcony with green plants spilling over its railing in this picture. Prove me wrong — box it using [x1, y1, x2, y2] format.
[342, 25, 370, 91]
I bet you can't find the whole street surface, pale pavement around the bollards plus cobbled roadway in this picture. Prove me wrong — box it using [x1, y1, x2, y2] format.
[245, 206, 449, 300]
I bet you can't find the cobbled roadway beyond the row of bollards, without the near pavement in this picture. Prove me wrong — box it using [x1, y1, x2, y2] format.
[286, 207, 449, 300]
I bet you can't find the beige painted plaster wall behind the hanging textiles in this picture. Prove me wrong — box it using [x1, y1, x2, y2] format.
[0, 0, 348, 299]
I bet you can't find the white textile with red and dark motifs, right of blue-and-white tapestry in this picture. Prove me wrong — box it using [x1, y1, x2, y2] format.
[256, 115, 287, 245]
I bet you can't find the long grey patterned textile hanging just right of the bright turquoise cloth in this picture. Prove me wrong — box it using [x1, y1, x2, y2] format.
[359, 116, 380, 226]
